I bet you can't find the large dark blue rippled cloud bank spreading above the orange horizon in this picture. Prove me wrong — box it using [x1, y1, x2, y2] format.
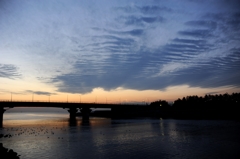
[49, 2, 240, 93]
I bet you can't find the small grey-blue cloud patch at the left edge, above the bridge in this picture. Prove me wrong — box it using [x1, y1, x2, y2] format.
[0, 64, 21, 79]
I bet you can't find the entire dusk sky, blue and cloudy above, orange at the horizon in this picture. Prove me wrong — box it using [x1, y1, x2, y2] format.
[0, 0, 240, 103]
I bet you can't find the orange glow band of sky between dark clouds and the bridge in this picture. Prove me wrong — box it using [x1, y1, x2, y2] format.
[0, 85, 240, 104]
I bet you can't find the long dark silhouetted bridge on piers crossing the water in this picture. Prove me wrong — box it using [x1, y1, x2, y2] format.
[0, 101, 134, 127]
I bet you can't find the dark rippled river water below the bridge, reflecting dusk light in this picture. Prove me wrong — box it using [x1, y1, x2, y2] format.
[0, 108, 240, 159]
